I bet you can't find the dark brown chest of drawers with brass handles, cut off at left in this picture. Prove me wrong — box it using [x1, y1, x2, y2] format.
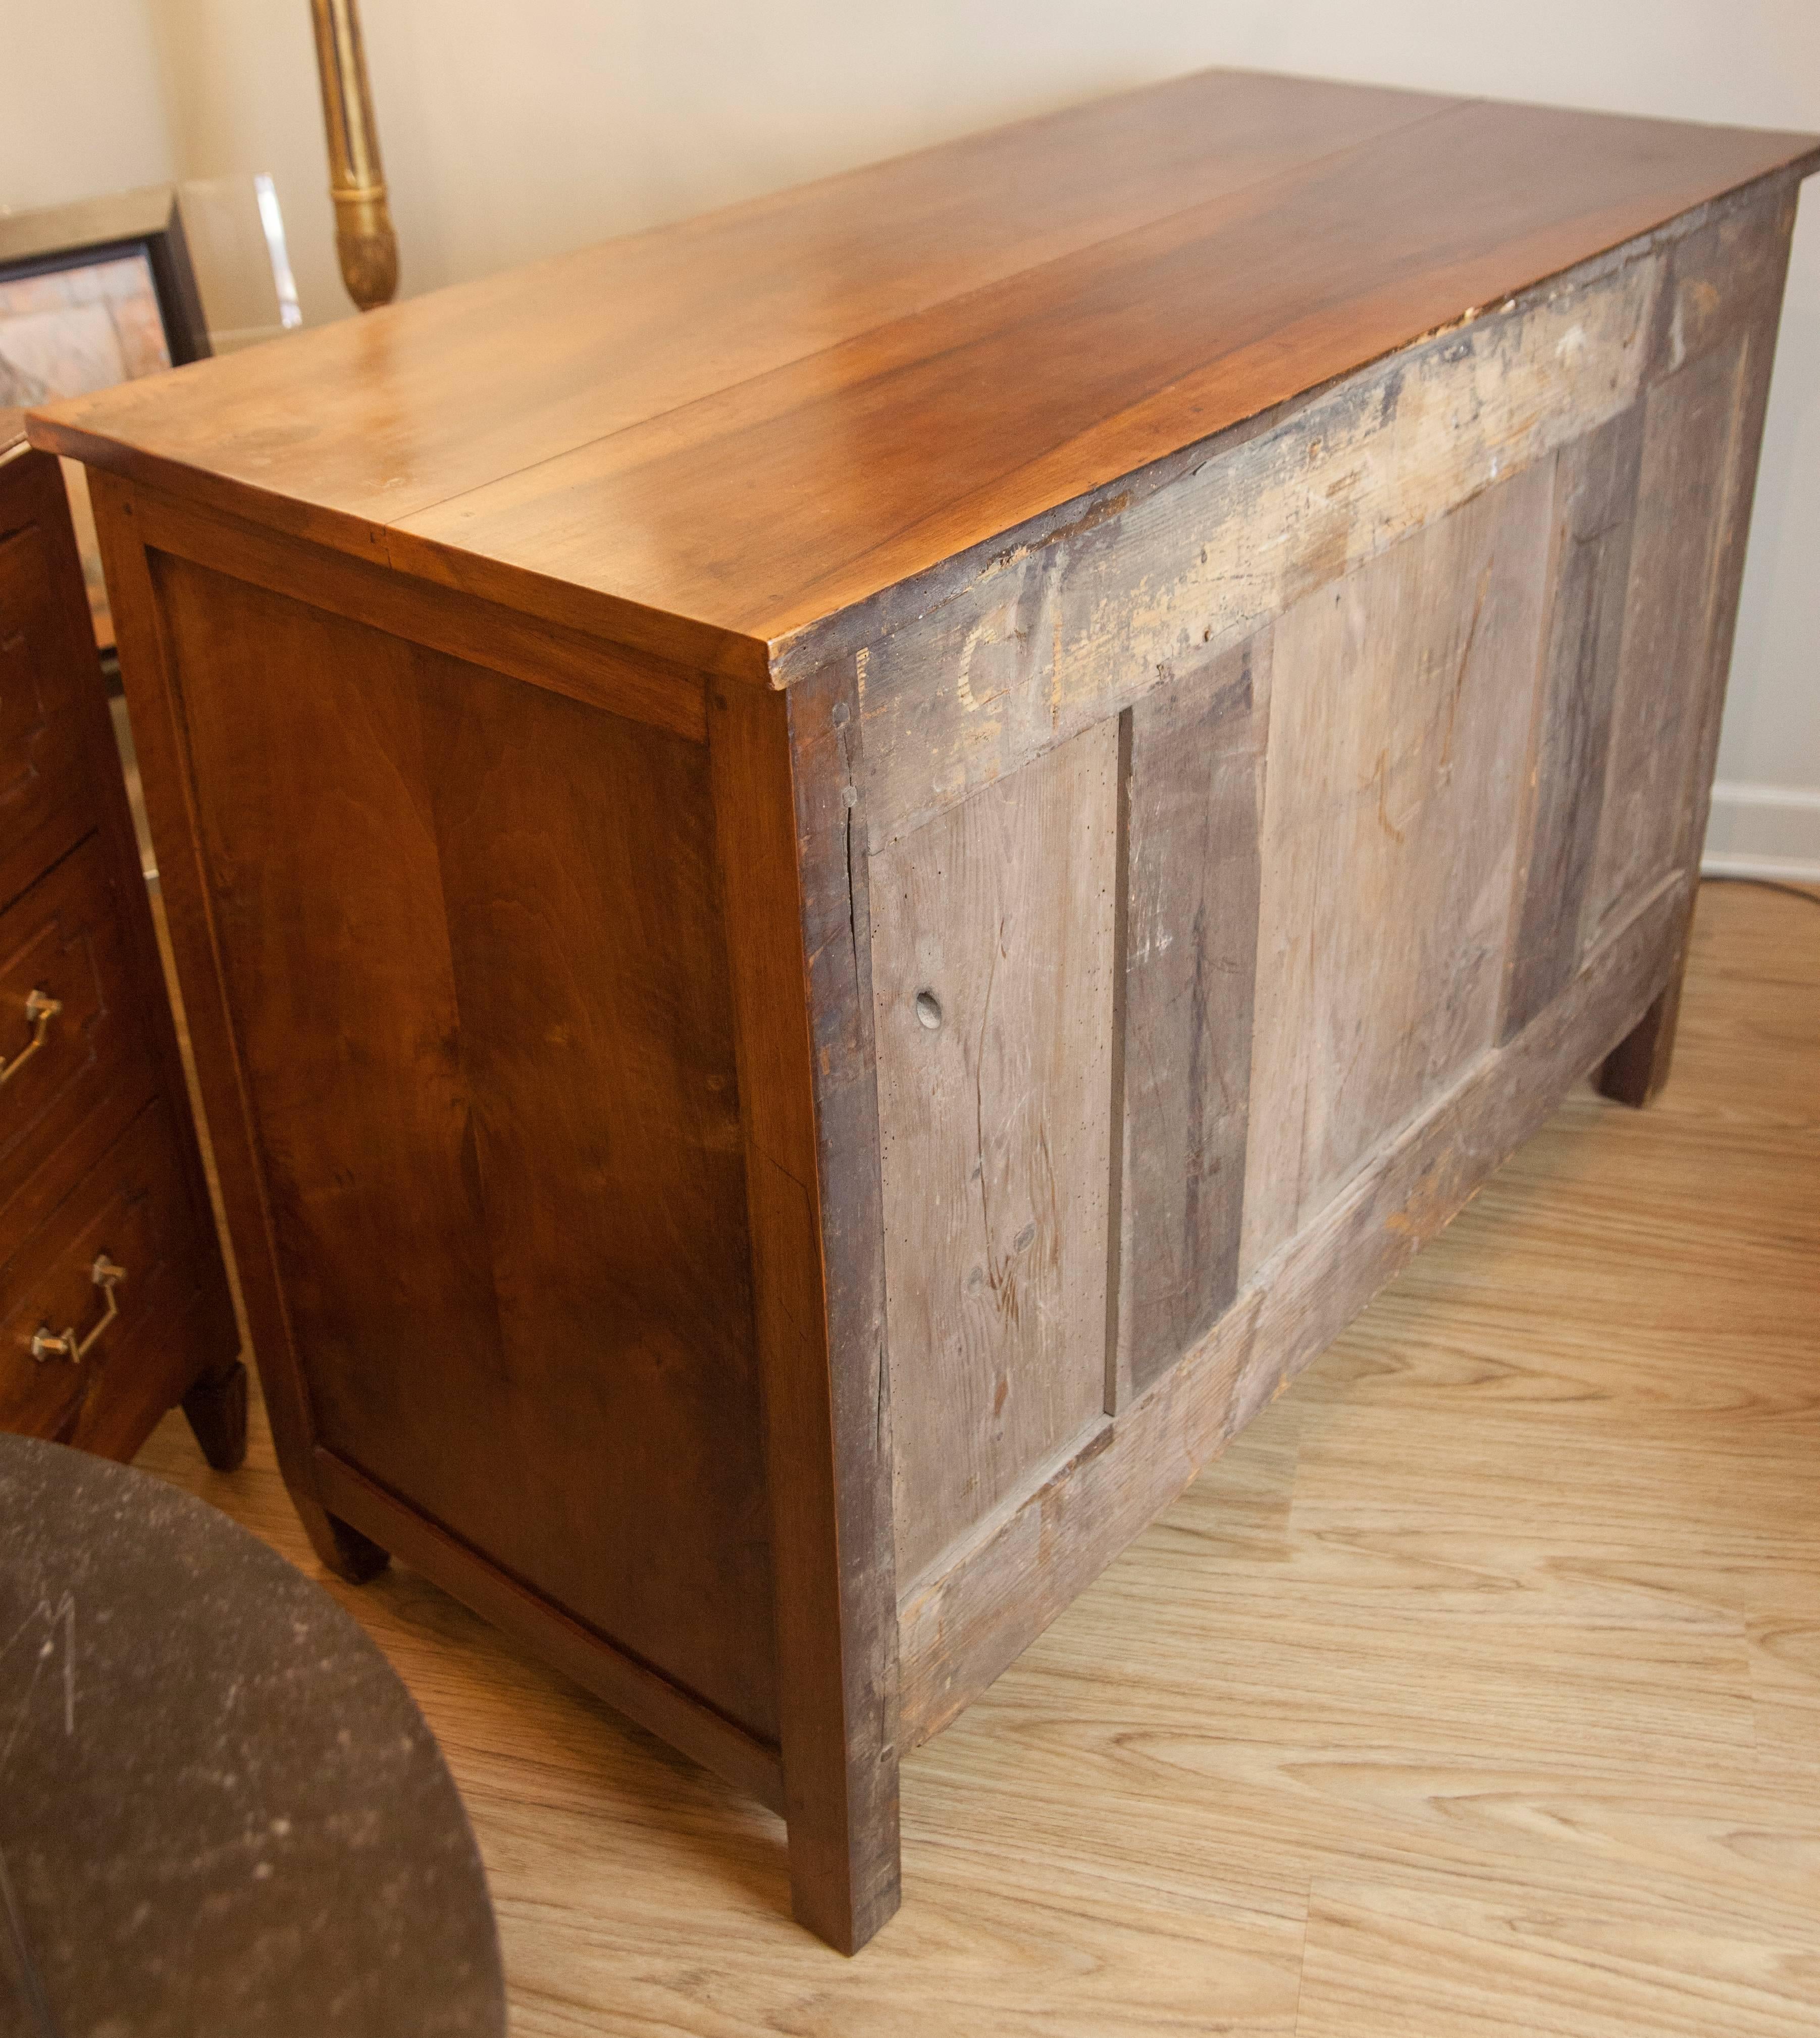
[0, 412, 246, 1465]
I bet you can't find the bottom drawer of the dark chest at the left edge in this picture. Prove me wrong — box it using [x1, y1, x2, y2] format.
[0, 1102, 200, 1451]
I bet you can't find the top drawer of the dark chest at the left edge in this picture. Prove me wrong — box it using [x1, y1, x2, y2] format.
[0, 524, 100, 903]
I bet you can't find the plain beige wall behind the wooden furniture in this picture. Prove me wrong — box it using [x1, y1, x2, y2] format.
[0, 0, 1820, 874]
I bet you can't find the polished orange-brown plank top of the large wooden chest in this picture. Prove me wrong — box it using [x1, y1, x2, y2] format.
[33, 71, 1816, 679]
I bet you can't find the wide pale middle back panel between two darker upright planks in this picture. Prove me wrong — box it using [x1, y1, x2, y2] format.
[1239, 465, 1553, 1280]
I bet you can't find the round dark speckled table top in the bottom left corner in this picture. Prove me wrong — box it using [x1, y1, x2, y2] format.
[0, 1437, 505, 2038]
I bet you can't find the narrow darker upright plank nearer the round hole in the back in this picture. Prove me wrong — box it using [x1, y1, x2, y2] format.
[1113, 634, 1270, 1406]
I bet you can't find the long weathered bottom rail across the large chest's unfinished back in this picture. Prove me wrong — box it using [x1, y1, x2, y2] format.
[899, 876, 1686, 1747]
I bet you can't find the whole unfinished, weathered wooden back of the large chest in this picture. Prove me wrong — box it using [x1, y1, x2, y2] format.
[876, 179, 1791, 1739]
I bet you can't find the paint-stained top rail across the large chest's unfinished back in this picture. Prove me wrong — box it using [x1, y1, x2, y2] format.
[860, 250, 1663, 848]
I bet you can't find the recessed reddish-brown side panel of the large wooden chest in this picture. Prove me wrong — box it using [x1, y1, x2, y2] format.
[152, 554, 778, 1745]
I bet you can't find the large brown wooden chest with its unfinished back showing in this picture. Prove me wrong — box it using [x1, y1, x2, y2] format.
[33, 73, 1816, 1948]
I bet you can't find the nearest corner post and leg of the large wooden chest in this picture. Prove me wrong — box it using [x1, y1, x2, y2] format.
[709, 681, 899, 1952]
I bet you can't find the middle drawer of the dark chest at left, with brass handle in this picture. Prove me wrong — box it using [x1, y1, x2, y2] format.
[0, 836, 155, 1259]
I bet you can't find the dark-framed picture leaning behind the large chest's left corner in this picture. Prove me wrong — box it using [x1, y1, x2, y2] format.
[0, 185, 210, 648]
